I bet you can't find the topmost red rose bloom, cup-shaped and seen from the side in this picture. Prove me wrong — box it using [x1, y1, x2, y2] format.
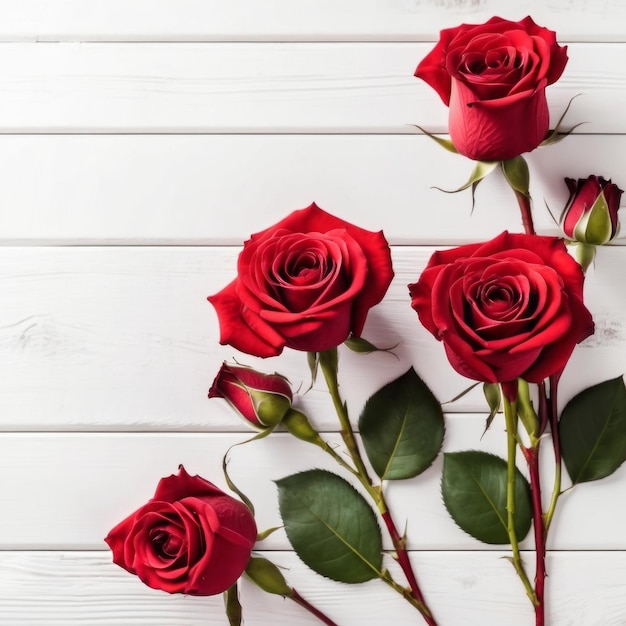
[415, 17, 567, 161]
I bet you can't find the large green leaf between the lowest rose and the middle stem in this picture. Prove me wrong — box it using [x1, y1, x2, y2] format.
[276, 469, 382, 583]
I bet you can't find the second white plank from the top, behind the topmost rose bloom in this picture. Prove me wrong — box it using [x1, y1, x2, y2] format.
[0, 43, 626, 133]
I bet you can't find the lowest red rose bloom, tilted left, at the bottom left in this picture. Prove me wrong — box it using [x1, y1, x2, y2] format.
[105, 466, 257, 596]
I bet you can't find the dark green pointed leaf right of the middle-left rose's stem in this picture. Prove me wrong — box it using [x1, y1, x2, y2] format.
[359, 368, 445, 480]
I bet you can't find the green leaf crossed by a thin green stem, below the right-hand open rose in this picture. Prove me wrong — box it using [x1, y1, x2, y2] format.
[441, 450, 532, 544]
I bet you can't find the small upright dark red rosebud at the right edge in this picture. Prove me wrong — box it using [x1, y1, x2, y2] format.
[561, 176, 624, 246]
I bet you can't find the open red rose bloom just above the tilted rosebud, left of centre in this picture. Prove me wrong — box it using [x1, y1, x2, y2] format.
[209, 204, 393, 357]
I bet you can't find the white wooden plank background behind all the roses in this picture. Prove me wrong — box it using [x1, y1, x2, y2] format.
[0, 0, 626, 626]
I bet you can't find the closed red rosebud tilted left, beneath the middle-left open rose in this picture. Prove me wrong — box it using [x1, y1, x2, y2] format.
[209, 363, 293, 430]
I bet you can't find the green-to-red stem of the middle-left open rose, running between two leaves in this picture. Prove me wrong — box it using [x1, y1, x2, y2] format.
[320, 348, 437, 626]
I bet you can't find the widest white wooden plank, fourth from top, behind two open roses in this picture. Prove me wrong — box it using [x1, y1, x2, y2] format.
[0, 246, 626, 430]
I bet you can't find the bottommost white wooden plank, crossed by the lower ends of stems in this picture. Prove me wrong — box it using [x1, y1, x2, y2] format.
[0, 552, 626, 626]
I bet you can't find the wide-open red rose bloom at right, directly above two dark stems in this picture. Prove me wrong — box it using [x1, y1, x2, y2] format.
[409, 232, 593, 390]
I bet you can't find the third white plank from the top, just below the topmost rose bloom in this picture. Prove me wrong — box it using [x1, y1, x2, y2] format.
[0, 134, 626, 245]
